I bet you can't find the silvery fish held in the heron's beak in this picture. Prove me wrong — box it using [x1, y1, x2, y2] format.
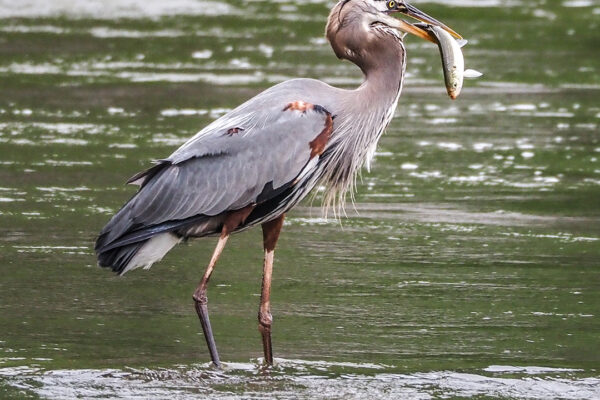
[418, 24, 482, 100]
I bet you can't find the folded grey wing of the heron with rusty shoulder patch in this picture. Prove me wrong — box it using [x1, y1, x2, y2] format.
[101, 102, 332, 244]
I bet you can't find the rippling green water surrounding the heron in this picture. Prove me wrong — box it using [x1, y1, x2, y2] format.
[0, 0, 600, 399]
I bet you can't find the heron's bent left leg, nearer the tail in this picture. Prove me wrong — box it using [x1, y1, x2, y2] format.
[192, 229, 229, 368]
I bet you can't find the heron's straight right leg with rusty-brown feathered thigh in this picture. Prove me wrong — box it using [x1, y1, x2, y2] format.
[258, 215, 285, 365]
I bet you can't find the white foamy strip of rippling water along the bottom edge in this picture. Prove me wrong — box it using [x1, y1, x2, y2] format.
[0, 359, 600, 400]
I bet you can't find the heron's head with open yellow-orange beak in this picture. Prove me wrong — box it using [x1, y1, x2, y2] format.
[326, 0, 461, 62]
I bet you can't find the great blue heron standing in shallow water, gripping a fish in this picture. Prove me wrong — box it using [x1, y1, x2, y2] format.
[95, 0, 460, 366]
